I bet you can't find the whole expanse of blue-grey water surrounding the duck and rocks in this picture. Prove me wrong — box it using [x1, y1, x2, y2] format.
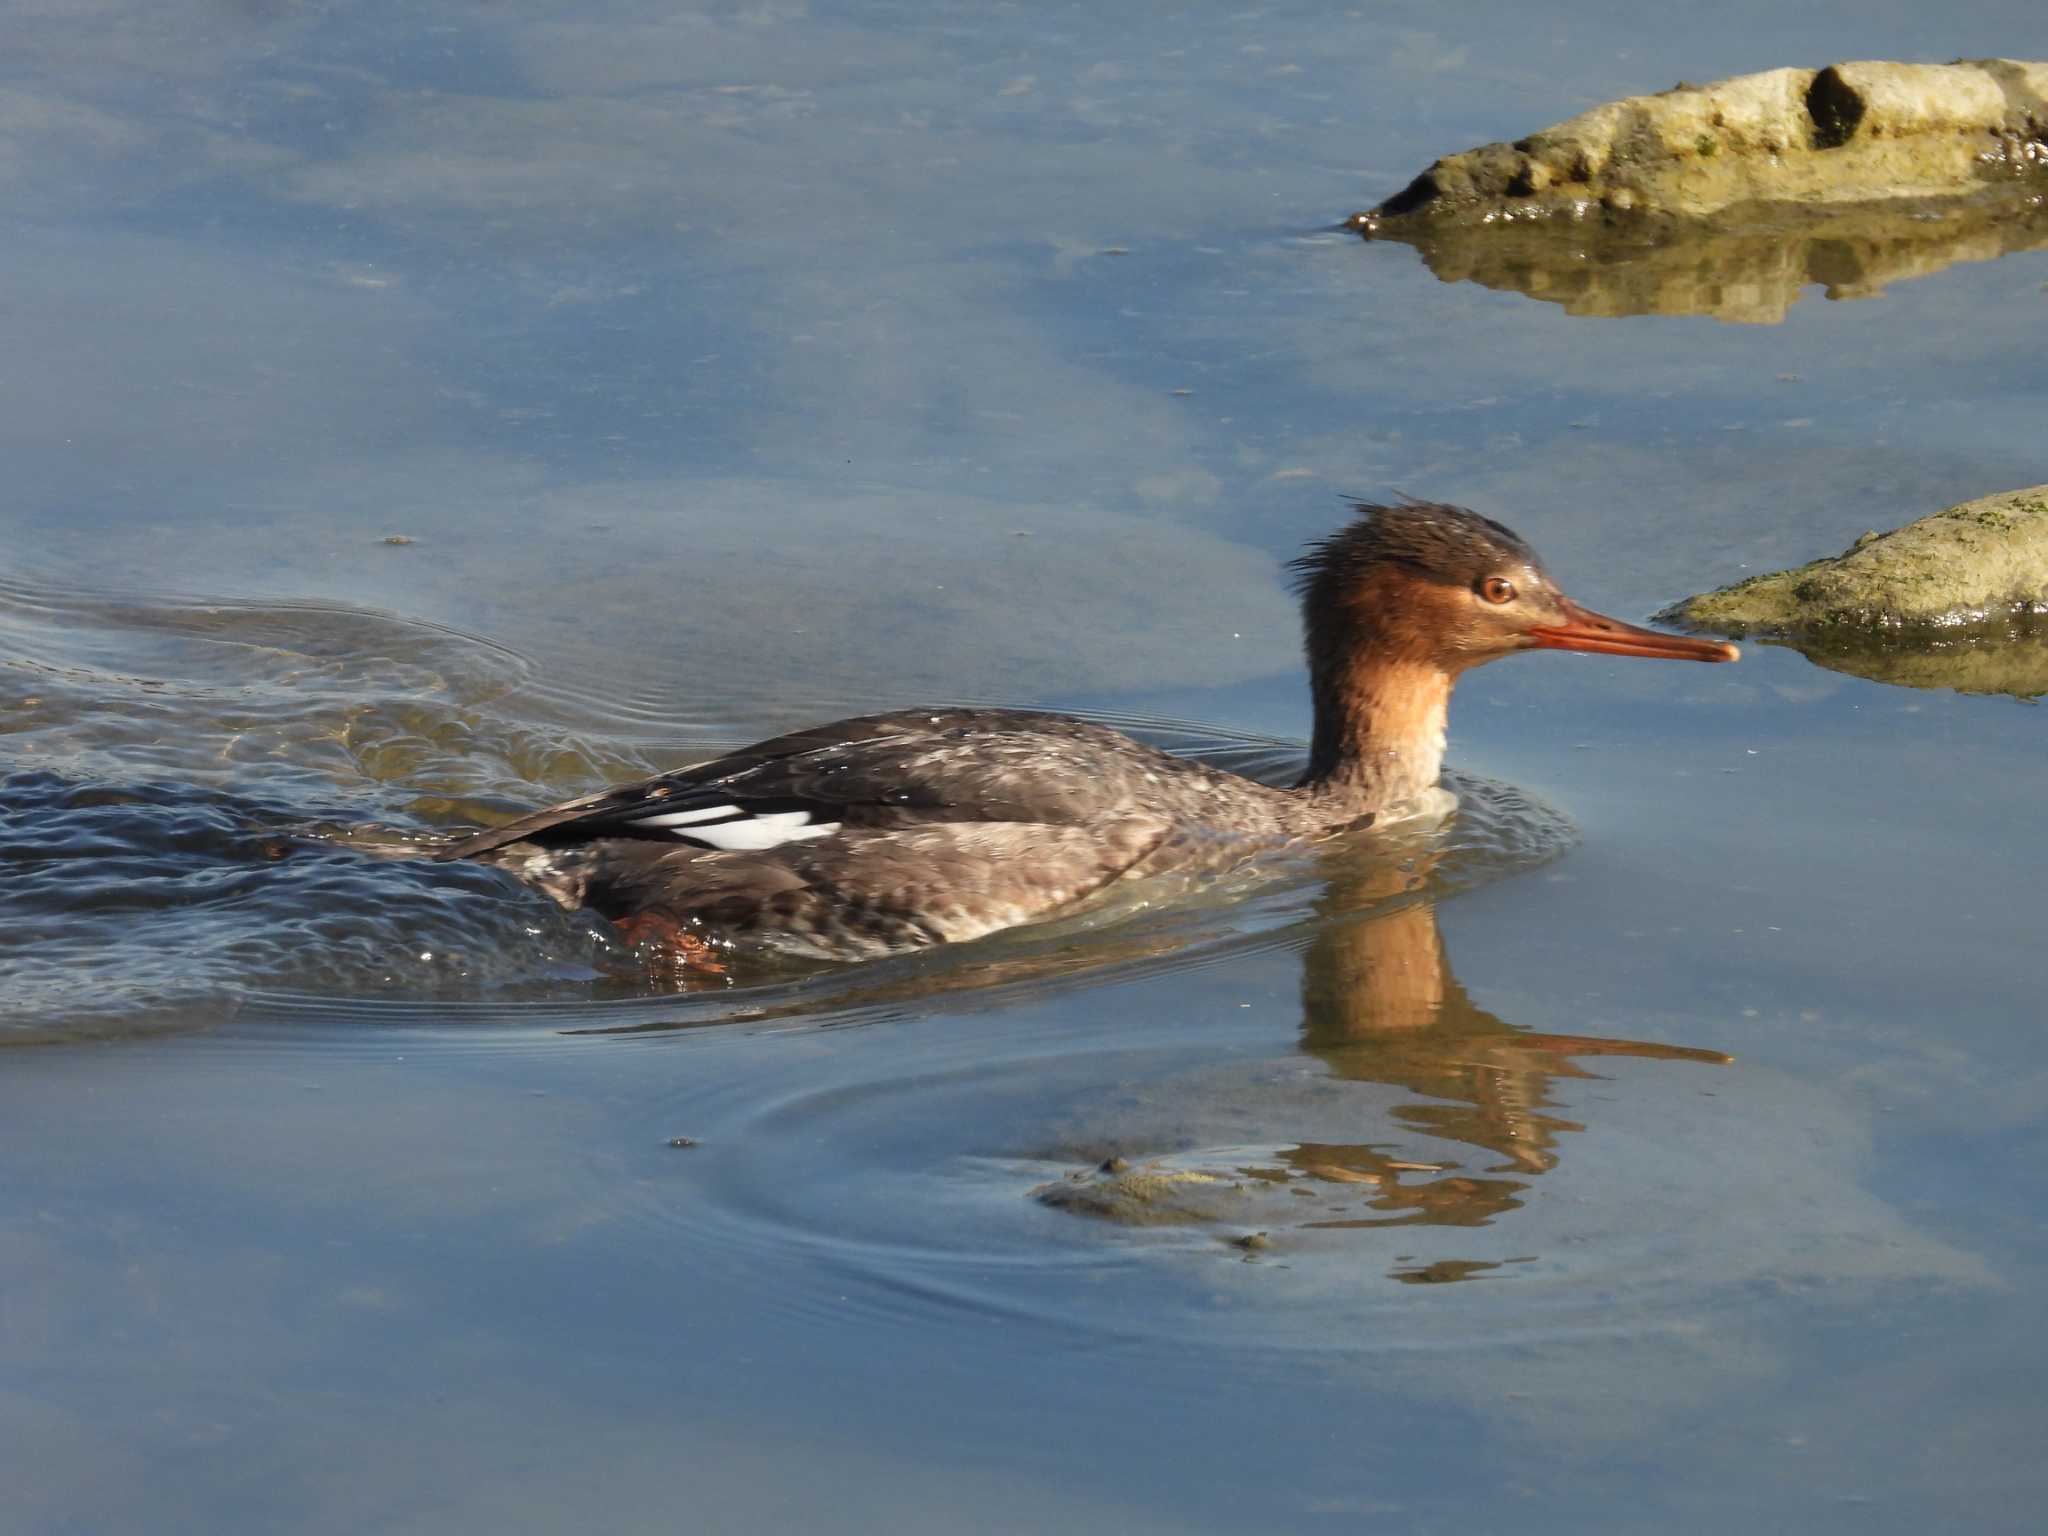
[0, 0, 2048, 1532]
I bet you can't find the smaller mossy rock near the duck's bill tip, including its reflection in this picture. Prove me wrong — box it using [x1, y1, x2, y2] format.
[1659, 485, 2048, 698]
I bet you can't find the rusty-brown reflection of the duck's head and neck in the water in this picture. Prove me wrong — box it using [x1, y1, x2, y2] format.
[1036, 850, 1731, 1253]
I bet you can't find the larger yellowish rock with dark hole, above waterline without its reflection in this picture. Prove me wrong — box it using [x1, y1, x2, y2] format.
[1354, 59, 2048, 236]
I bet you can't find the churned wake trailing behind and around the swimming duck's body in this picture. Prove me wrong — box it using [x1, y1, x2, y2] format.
[0, 573, 1571, 1042]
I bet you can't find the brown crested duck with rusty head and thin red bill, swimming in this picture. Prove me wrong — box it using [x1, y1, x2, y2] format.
[432, 500, 1739, 975]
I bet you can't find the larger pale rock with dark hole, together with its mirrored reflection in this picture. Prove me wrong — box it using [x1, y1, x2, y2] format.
[1348, 59, 2048, 324]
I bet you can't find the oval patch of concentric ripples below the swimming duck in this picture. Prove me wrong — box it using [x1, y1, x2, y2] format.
[592, 966, 1956, 1358]
